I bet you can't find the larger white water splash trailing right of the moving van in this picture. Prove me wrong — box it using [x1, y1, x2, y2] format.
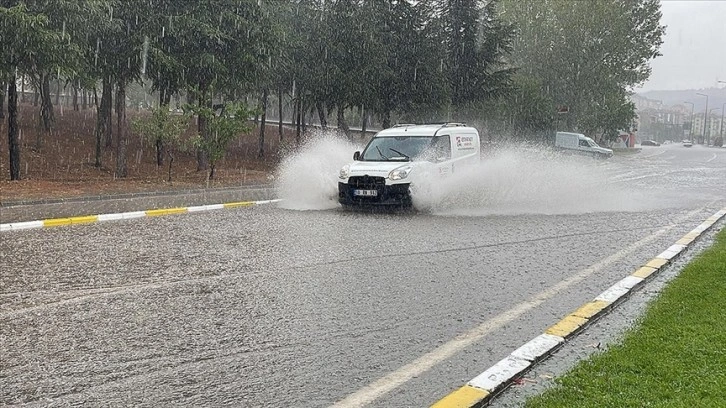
[411, 147, 652, 216]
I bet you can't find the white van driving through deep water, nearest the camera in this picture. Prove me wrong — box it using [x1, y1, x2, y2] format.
[338, 123, 480, 207]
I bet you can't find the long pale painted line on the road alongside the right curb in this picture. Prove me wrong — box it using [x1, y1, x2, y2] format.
[333, 207, 705, 408]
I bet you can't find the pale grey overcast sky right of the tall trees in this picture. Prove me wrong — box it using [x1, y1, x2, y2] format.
[636, 0, 726, 91]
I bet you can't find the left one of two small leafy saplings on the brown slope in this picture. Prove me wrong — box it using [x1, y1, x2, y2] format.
[131, 105, 189, 182]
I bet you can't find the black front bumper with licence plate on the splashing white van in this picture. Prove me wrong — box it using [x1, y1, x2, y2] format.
[338, 177, 412, 207]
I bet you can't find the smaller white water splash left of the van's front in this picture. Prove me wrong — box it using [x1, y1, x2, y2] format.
[275, 133, 361, 210]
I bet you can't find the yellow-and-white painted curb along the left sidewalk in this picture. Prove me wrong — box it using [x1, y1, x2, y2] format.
[0, 199, 280, 232]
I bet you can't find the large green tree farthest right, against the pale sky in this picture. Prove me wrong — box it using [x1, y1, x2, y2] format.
[501, 0, 664, 135]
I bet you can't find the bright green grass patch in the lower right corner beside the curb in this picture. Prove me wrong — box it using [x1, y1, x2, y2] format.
[526, 229, 726, 408]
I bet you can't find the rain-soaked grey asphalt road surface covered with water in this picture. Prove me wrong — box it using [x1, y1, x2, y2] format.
[0, 145, 726, 407]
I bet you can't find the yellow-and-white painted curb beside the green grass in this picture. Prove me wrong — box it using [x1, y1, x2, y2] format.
[432, 208, 726, 408]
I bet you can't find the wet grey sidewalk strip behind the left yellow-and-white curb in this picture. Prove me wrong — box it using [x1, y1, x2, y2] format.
[0, 185, 275, 224]
